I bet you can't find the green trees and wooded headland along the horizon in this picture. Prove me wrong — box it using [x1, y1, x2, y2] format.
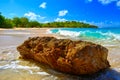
[0, 13, 97, 28]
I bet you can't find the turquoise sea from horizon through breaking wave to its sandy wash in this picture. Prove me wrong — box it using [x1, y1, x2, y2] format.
[49, 28, 120, 46]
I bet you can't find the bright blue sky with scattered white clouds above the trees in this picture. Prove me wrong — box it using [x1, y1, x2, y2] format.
[0, 0, 120, 27]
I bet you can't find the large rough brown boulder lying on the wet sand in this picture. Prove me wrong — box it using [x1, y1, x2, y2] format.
[17, 37, 110, 75]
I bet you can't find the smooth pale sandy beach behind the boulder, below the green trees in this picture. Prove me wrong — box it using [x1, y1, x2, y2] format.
[0, 28, 55, 48]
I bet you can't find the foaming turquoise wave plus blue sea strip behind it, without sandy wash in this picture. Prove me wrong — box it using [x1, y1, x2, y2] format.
[50, 28, 120, 41]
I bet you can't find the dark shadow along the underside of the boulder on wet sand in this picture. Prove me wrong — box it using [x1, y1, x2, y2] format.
[24, 60, 120, 80]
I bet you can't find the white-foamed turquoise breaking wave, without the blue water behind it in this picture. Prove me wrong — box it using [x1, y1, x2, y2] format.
[49, 29, 120, 41]
